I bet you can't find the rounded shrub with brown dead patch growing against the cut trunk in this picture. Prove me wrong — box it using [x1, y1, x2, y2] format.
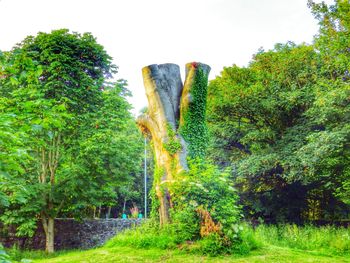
[169, 160, 242, 255]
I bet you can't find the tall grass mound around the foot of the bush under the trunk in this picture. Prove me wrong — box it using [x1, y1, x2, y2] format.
[105, 221, 261, 256]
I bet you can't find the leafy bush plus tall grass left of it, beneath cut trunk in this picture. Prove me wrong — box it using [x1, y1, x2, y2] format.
[106, 161, 252, 256]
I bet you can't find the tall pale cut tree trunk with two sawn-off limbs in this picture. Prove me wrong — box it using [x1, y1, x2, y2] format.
[137, 62, 210, 225]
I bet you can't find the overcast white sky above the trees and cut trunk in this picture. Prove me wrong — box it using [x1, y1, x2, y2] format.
[0, 0, 333, 114]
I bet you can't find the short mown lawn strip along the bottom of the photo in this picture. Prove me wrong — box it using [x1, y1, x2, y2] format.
[28, 246, 350, 263]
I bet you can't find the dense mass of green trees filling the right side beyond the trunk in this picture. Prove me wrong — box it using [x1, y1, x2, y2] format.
[208, 1, 350, 225]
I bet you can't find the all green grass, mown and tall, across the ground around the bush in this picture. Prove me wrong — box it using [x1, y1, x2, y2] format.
[8, 225, 350, 263]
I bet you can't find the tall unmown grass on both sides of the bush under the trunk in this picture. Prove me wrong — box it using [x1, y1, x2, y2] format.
[106, 223, 350, 255]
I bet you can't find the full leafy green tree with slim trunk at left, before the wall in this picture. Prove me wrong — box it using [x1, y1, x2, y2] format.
[1, 30, 140, 252]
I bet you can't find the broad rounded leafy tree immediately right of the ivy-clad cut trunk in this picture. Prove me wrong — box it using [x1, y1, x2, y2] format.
[208, 43, 318, 223]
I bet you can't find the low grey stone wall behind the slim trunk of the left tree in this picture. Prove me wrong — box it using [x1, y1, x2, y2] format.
[0, 219, 142, 250]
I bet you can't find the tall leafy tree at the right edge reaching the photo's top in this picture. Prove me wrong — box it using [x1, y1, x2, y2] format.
[301, 0, 350, 204]
